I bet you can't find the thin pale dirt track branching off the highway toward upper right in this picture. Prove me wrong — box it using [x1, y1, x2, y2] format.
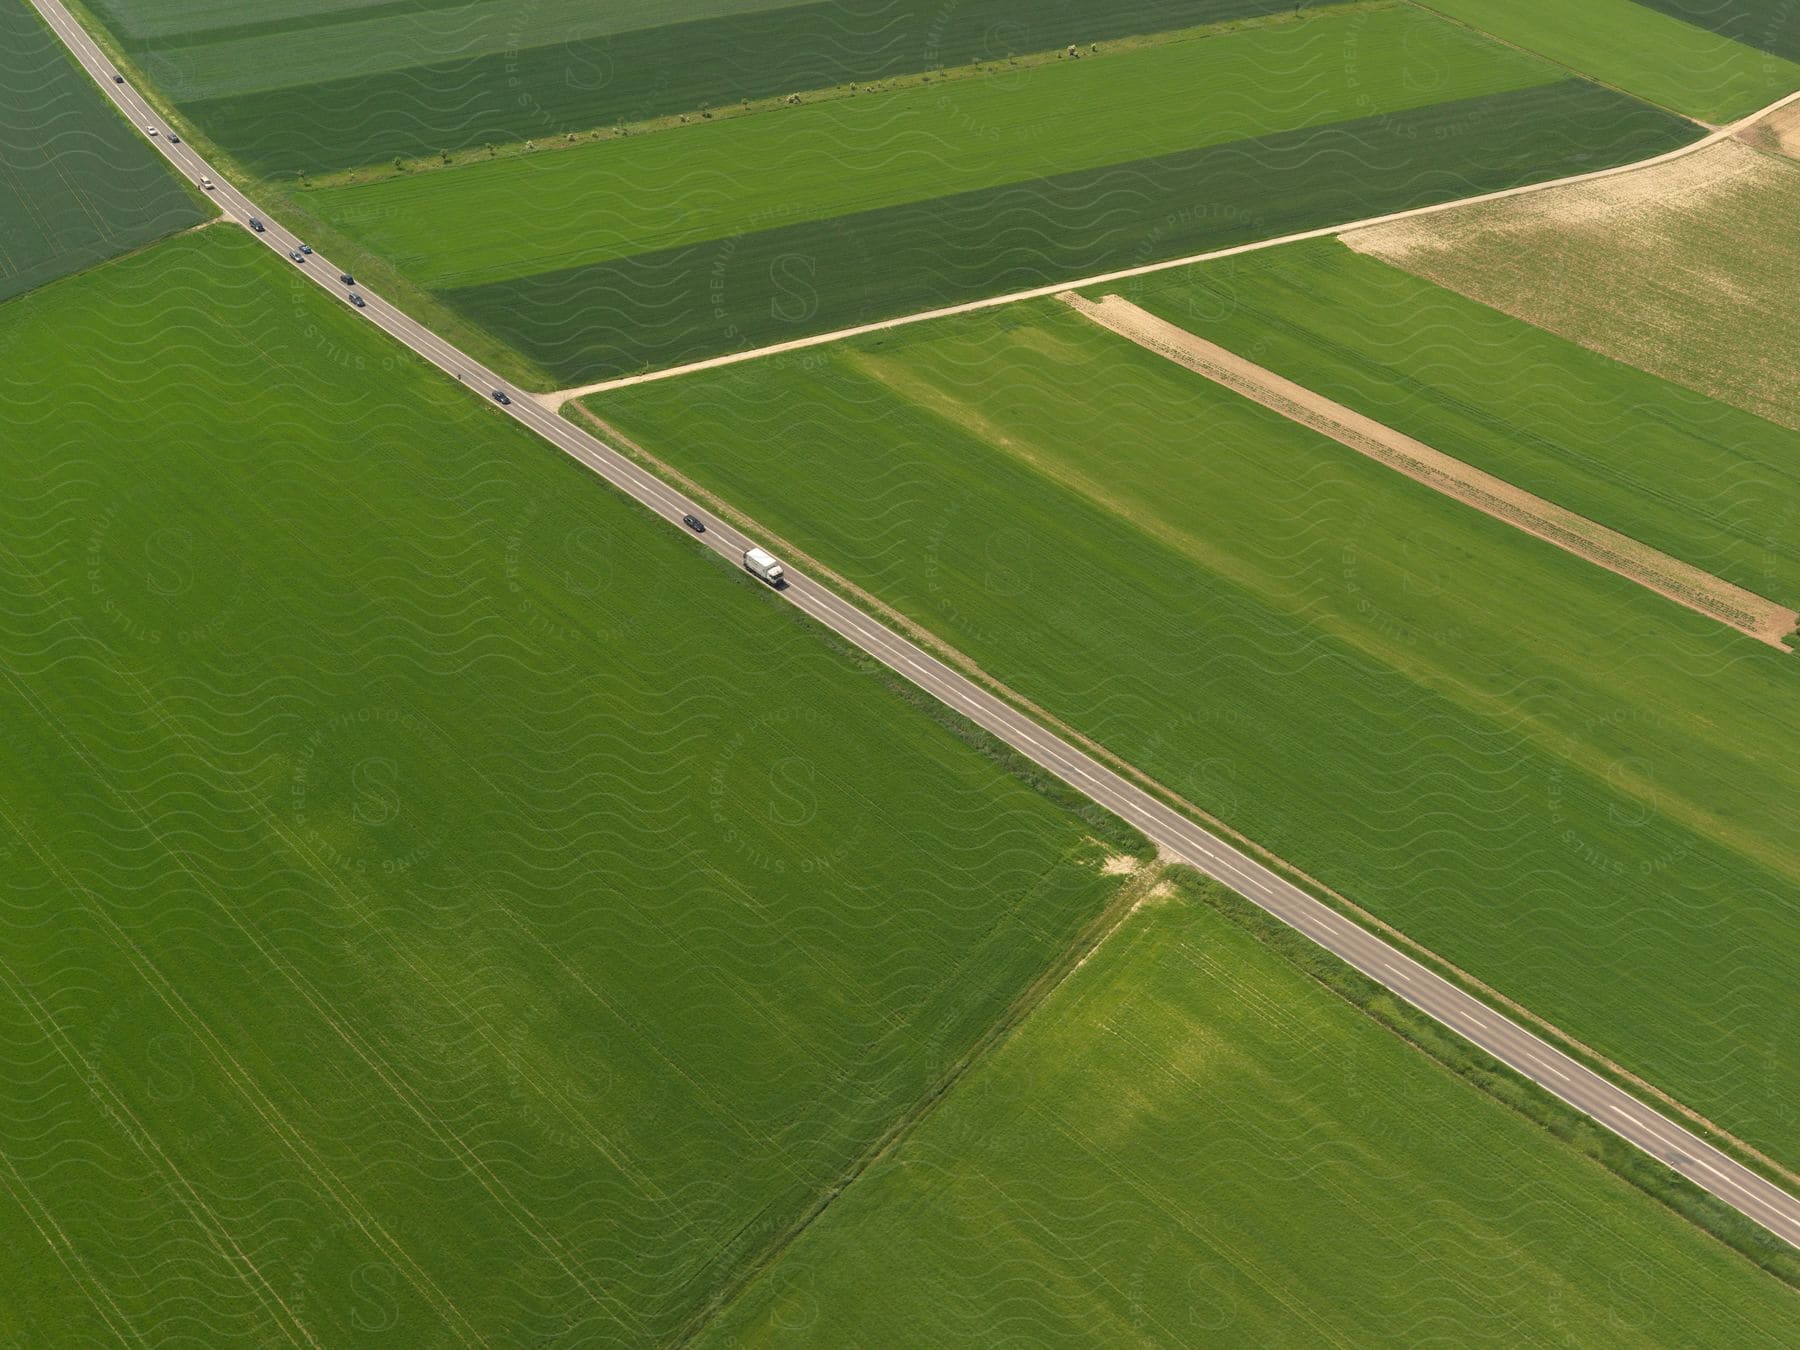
[547, 90, 1800, 412]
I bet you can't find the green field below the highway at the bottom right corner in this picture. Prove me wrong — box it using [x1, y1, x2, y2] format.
[707, 882, 1800, 1346]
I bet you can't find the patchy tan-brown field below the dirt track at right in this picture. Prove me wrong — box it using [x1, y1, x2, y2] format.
[1346, 140, 1800, 433]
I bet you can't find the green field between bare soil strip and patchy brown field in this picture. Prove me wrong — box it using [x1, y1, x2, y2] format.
[1120, 237, 1800, 603]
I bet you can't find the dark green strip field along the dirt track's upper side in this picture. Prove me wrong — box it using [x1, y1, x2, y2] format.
[445, 81, 1696, 383]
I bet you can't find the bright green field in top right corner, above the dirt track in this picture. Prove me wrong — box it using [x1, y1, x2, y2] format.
[1424, 0, 1800, 122]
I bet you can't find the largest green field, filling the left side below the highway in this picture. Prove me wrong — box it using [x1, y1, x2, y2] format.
[0, 229, 1136, 1345]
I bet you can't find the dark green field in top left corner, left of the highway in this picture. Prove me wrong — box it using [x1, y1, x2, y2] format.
[0, 4, 203, 301]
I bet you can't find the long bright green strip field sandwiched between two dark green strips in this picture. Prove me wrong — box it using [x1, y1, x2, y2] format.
[302, 5, 1562, 290]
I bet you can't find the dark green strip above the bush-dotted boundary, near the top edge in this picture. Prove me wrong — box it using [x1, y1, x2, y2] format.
[184, 0, 1325, 175]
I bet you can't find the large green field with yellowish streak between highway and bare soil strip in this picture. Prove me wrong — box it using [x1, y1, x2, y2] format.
[589, 301, 1800, 1161]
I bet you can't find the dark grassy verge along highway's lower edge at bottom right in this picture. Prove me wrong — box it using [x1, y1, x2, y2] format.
[1170, 868, 1800, 1289]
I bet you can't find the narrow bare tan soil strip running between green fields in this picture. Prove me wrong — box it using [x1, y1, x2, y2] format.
[1058, 292, 1800, 652]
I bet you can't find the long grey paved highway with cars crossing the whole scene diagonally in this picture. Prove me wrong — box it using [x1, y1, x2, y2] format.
[32, 0, 1800, 1247]
